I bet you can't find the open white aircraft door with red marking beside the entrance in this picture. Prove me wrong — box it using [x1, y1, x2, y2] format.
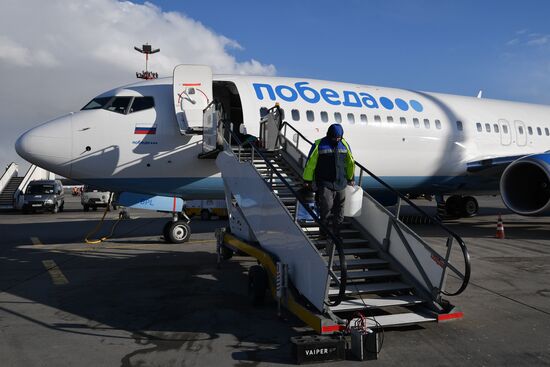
[173, 65, 212, 135]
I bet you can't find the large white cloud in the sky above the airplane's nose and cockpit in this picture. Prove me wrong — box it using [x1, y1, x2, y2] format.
[0, 0, 276, 170]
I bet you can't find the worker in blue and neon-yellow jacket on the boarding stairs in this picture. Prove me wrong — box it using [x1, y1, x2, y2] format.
[303, 124, 355, 239]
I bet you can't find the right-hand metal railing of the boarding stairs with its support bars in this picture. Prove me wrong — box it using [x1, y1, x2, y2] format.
[280, 121, 471, 297]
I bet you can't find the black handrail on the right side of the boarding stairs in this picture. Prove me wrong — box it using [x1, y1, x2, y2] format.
[280, 121, 471, 296]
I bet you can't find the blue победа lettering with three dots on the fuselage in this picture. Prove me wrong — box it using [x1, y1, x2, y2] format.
[252, 82, 424, 112]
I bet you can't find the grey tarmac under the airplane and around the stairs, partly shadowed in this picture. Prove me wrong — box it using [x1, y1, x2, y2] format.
[0, 197, 550, 367]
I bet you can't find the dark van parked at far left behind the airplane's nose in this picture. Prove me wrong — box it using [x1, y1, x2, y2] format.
[22, 180, 65, 213]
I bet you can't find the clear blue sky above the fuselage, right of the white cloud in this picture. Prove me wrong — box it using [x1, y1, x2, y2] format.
[136, 0, 550, 104]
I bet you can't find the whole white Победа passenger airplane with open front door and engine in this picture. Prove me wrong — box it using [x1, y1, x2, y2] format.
[15, 65, 550, 243]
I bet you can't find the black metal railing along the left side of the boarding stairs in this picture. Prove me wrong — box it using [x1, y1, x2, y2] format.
[220, 114, 347, 306]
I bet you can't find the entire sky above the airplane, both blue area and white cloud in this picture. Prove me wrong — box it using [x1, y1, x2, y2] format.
[0, 0, 550, 168]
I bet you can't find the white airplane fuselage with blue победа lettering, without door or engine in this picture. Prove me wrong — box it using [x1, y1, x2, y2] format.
[16, 75, 550, 199]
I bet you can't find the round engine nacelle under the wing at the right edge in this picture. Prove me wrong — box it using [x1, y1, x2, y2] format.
[500, 153, 550, 216]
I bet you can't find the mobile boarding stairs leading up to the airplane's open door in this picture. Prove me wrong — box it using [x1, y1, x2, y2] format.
[209, 107, 470, 333]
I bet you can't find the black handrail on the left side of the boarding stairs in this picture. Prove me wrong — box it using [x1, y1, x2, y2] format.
[220, 115, 347, 306]
